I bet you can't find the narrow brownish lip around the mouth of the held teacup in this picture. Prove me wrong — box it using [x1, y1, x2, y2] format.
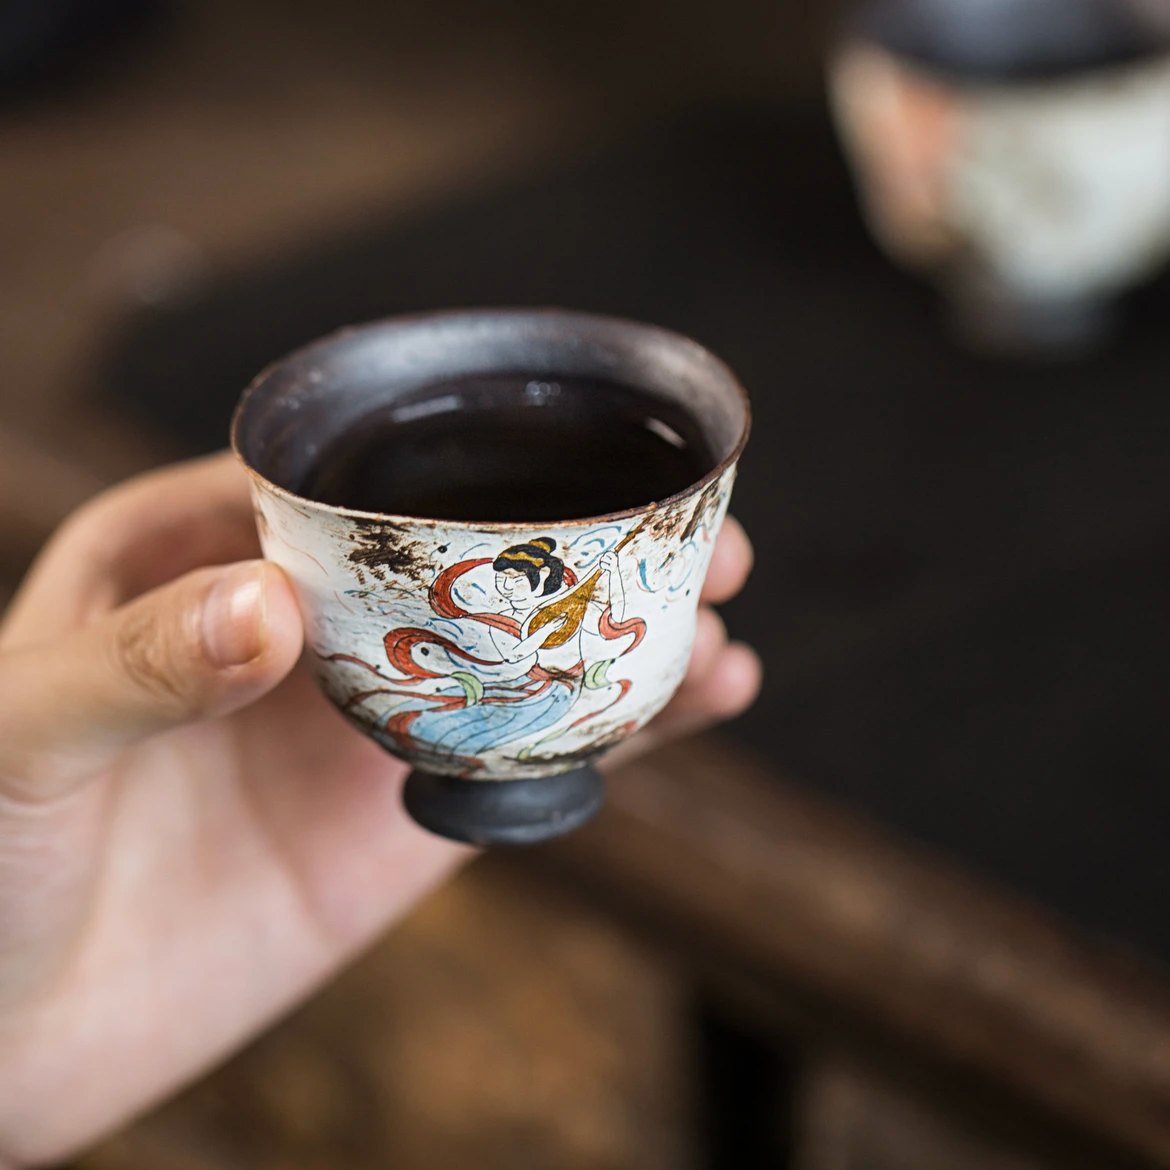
[230, 307, 752, 532]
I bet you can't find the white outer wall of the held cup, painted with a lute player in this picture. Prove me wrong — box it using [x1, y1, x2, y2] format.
[253, 467, 735, 780]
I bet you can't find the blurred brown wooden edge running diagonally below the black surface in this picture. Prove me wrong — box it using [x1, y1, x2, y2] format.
[539, 739, 1170, 1165]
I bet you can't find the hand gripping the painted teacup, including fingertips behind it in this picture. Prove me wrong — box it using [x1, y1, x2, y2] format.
[0, 456, 759, 1166]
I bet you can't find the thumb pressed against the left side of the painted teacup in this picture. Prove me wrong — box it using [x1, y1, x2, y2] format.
[0, 560, 303, 800]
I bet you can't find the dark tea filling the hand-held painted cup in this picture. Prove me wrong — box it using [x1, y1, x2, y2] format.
[300, 374, 716, 523]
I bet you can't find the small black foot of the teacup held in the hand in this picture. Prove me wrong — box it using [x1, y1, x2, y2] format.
[402, 765, 605, 845]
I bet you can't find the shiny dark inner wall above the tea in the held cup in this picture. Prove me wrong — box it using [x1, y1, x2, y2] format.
[232, 310, 750, 519]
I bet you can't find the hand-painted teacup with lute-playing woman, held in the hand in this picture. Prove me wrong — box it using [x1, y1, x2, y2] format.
[232, 310, 750, 844]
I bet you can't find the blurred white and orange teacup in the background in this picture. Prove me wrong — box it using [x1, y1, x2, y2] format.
[830, 0, 1170, 352]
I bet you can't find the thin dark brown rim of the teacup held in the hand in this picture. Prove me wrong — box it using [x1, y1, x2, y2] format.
[230, 308, 751, 532]
